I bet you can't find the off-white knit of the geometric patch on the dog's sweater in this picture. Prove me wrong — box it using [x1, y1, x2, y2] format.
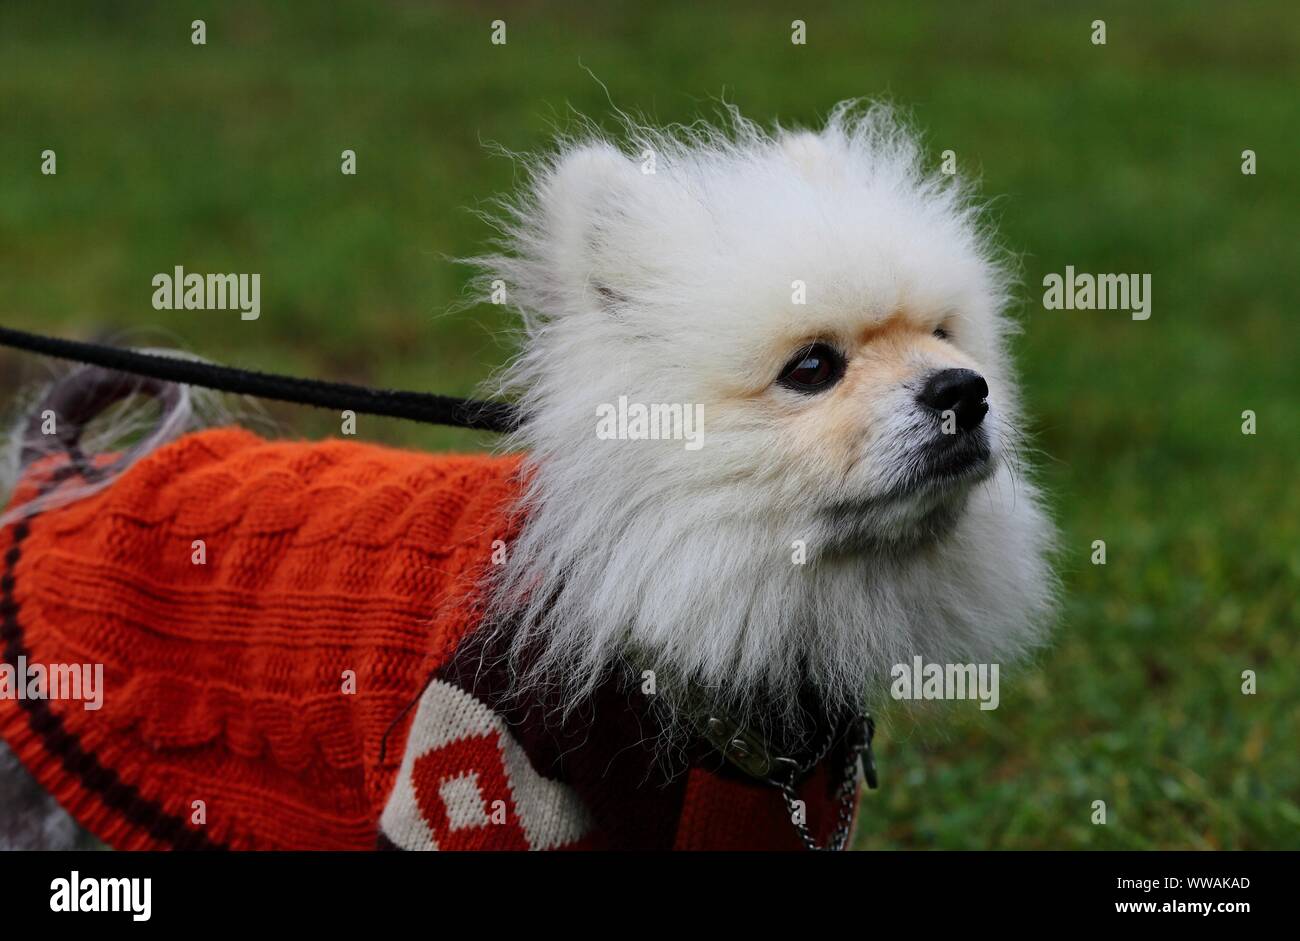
[380, 680, 593, 850]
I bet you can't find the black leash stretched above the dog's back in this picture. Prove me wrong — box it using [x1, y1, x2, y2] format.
[0, 326, 519, 432]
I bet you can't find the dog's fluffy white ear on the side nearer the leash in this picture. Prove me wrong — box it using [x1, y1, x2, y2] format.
[538, 143, 647, 313]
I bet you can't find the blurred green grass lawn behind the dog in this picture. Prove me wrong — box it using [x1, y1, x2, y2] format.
[0, 0, 1300, 849]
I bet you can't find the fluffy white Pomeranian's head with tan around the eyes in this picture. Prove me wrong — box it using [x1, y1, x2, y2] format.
[484, 102, 1050, 733]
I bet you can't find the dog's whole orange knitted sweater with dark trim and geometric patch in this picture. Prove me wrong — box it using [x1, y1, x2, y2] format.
[0, 429, 847, 849]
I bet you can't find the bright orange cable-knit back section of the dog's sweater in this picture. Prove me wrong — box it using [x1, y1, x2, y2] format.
[0, 429, 517, 849]
